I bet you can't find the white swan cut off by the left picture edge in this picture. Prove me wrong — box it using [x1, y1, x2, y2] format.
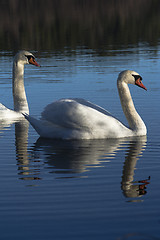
[0, 50, 40, 120]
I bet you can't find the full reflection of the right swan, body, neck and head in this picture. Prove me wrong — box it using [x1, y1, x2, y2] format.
[29, 137, 149, 198]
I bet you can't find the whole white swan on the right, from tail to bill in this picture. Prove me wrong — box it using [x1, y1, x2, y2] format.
[25, 70, 147, 139]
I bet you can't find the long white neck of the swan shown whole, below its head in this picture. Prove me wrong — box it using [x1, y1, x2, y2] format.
[117, 81, 146, 135]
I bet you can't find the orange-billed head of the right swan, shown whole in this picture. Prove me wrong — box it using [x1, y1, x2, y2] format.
[118, 70, 147, 90]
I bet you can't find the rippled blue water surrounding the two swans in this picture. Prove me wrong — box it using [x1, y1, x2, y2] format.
[0, 45, 160, 240]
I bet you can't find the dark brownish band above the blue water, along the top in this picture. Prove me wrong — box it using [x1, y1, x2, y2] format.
[0, 0, 160, 52]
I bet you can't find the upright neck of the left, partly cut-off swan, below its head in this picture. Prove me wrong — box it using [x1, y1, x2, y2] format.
[12, 61, 29, 113]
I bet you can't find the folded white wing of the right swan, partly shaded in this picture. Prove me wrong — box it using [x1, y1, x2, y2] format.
[41, 99, 117, 130]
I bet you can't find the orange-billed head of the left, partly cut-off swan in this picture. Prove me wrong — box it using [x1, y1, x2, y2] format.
[14, 50, 40, 67]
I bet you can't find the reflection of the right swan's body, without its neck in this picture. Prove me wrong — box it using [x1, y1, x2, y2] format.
[31, 138, 119, 174]
